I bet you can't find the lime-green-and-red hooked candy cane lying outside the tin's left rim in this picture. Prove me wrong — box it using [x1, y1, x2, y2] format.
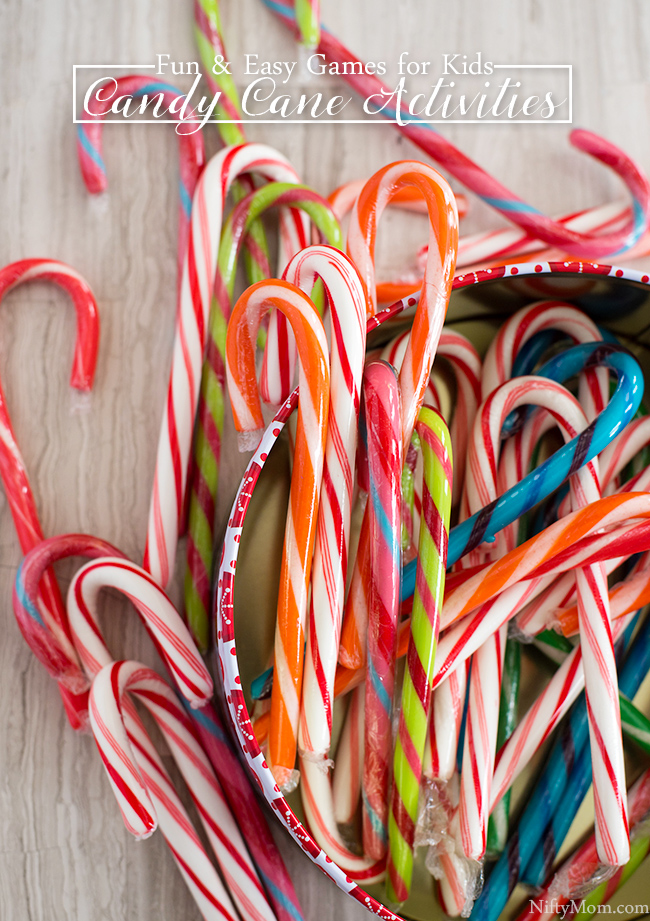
[185, 183, 336, 652]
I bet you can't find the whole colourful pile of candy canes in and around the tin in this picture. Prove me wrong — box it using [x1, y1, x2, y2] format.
[8, 0, 650, 921]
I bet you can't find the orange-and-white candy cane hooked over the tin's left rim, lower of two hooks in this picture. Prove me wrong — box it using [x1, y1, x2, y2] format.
[226, 281, 330, 791]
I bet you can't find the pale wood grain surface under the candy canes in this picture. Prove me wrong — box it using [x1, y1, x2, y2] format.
[0, 0, 650, 921]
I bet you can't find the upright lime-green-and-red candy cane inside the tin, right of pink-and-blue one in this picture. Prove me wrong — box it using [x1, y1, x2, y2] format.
[387, 407, 452, 902]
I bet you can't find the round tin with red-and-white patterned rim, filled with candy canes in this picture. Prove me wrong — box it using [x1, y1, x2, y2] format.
[215, 161, 650, 919]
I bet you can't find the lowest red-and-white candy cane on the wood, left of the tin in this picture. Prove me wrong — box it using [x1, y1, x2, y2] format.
[90, 662, 275, 921]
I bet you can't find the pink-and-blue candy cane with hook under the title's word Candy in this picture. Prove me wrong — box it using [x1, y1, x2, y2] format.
[77, 74, 205, 284]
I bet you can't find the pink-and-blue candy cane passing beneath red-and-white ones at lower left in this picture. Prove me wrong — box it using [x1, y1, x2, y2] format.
[14, 534, 302, 921]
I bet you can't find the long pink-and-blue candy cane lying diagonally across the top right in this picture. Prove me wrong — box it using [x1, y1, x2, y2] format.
[263, 0, 650, 259]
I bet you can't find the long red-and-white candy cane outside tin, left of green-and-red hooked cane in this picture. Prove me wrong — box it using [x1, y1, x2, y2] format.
[143, 144, 297, 586]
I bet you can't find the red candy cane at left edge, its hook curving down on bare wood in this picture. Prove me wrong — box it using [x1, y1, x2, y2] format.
[0, 259, 99, 729]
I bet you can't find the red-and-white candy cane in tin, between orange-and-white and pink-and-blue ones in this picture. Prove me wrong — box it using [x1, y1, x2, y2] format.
[284, 245, 366, 759]
